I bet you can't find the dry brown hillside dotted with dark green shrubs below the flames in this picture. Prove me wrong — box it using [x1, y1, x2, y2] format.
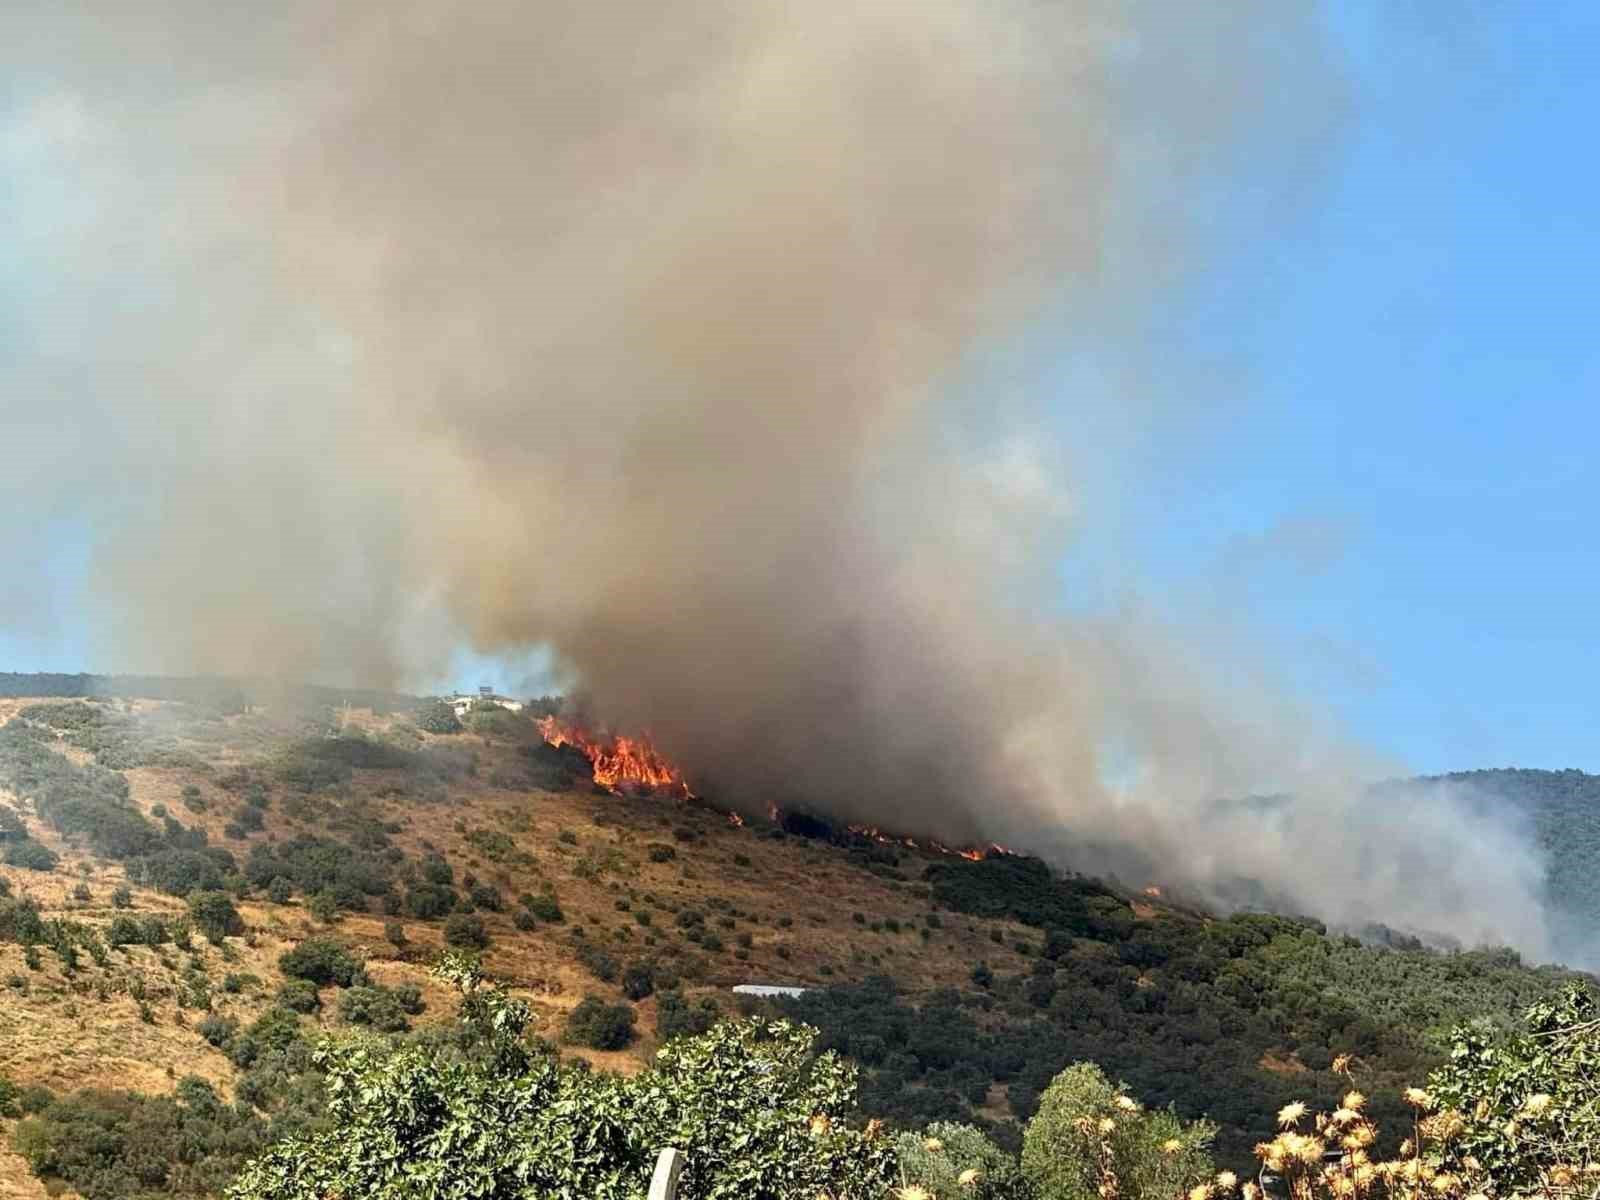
[0, 693, 1580, 1197]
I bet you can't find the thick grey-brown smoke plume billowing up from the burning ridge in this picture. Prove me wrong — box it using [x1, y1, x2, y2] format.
[0, 0, 1546, 952]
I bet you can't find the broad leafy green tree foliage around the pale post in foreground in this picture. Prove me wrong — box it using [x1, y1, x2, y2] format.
[229, 960, 894, 1200]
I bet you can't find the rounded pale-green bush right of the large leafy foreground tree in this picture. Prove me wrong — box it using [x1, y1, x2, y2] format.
[1022, 1062, 1216, 1200]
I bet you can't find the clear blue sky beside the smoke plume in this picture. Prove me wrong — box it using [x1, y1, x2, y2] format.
[0, 0, 1600, 771]
